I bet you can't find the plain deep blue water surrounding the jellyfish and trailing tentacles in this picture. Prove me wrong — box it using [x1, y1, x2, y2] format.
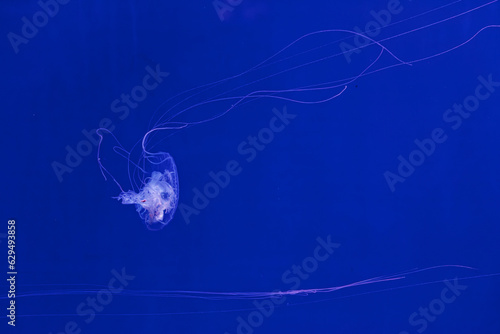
[0, 0, 500, 333]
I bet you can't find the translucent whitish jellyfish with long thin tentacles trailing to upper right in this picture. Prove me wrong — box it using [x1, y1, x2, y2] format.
[97, 1, 500, 230]
